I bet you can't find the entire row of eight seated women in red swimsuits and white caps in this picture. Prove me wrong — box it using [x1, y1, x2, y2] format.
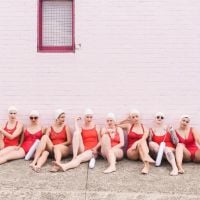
[0, 106, 200, 176]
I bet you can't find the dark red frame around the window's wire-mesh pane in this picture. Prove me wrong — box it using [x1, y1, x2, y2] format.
[37, 0, 75, 52]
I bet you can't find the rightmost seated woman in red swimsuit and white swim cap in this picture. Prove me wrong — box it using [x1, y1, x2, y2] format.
[176, 115, 200, 174]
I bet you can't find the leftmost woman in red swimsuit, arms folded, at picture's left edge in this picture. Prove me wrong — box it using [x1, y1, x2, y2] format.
[0, 106, 23, 156]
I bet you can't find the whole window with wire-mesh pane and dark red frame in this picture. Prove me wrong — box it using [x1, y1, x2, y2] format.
[38, 0, 75, 52]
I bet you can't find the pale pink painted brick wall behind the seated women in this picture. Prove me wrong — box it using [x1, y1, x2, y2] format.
[0, 0, 200, 127]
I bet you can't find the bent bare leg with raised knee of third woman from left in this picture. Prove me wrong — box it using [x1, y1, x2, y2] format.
[30, 135, 53, 167]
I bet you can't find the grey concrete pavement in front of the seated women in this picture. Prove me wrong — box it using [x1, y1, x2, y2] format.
[0, 159, 200, 200]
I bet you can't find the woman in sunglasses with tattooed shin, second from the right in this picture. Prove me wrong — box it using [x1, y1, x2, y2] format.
[149, 112, 178, 176]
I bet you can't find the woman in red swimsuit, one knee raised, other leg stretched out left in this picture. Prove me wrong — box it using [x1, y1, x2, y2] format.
[54, 109, 100, 171]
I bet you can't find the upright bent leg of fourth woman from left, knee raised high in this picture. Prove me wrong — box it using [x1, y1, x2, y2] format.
[72, 131, 84, 159]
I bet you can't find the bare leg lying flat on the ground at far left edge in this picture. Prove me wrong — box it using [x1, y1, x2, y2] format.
[0, 148, 25, 165]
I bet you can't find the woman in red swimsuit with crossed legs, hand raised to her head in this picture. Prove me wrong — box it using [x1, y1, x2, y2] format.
[118, 110, 155, 174]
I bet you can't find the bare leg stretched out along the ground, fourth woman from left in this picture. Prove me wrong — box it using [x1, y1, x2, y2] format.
[53, 150, 93, 171]
